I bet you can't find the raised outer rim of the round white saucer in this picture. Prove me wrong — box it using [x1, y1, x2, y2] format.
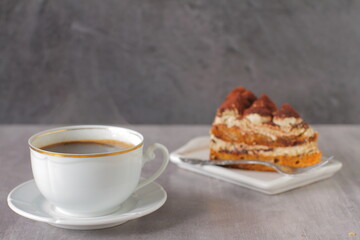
[7, 179, 167, 228]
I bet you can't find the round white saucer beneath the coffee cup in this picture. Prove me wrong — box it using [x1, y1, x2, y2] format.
[8, 180, 167, 230]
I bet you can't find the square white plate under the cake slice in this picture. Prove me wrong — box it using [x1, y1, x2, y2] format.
[170, 136, 342, 194]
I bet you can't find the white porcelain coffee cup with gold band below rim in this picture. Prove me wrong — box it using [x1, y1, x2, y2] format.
[29, 125, 169, 217]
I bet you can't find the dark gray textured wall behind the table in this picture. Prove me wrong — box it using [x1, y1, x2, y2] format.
[0, 0, 360, 123]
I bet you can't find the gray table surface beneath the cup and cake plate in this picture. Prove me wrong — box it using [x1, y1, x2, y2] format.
[0, 125, 360, 240]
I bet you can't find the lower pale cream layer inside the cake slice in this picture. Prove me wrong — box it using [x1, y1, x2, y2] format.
[210, 135, 319, 156]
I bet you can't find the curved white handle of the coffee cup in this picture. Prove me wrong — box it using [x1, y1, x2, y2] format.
[135, 143, 169, 191]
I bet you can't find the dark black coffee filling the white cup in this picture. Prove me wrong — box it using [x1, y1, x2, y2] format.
[40, 139, 134, 154]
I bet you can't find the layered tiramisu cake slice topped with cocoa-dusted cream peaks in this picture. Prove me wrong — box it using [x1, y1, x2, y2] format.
[210, 87, 321, 171]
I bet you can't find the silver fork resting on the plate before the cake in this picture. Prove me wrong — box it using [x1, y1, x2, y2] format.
[180, 156, 334, 176]
